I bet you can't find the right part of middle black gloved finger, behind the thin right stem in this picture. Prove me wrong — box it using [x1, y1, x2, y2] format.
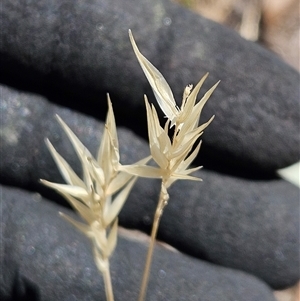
[125, 170, 300, 289]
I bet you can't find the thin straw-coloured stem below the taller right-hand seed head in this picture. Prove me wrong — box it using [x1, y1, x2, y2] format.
[138, 182, 169, 301]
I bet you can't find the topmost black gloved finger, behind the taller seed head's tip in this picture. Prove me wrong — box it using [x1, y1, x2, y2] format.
[0, 0, 300, 175]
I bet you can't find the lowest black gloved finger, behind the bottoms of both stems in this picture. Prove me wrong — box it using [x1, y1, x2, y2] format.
[0, 186, 275, 301]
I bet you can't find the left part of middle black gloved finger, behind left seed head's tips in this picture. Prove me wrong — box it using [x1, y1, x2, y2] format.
[0, 86, 150, 190]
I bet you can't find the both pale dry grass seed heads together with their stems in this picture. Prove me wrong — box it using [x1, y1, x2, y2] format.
[41, 30, 218, 301]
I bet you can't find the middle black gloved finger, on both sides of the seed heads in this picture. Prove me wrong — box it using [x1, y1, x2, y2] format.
[0, 87, 299, 289]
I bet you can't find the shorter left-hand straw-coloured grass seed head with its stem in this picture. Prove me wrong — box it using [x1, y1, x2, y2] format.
[41, 97, 150, 300]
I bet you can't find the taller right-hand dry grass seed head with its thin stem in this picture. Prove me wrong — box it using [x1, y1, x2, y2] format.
[125, 30, 219, 301]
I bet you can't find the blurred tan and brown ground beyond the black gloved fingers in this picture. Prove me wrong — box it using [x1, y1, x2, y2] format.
[174, 0, 300, 301]
